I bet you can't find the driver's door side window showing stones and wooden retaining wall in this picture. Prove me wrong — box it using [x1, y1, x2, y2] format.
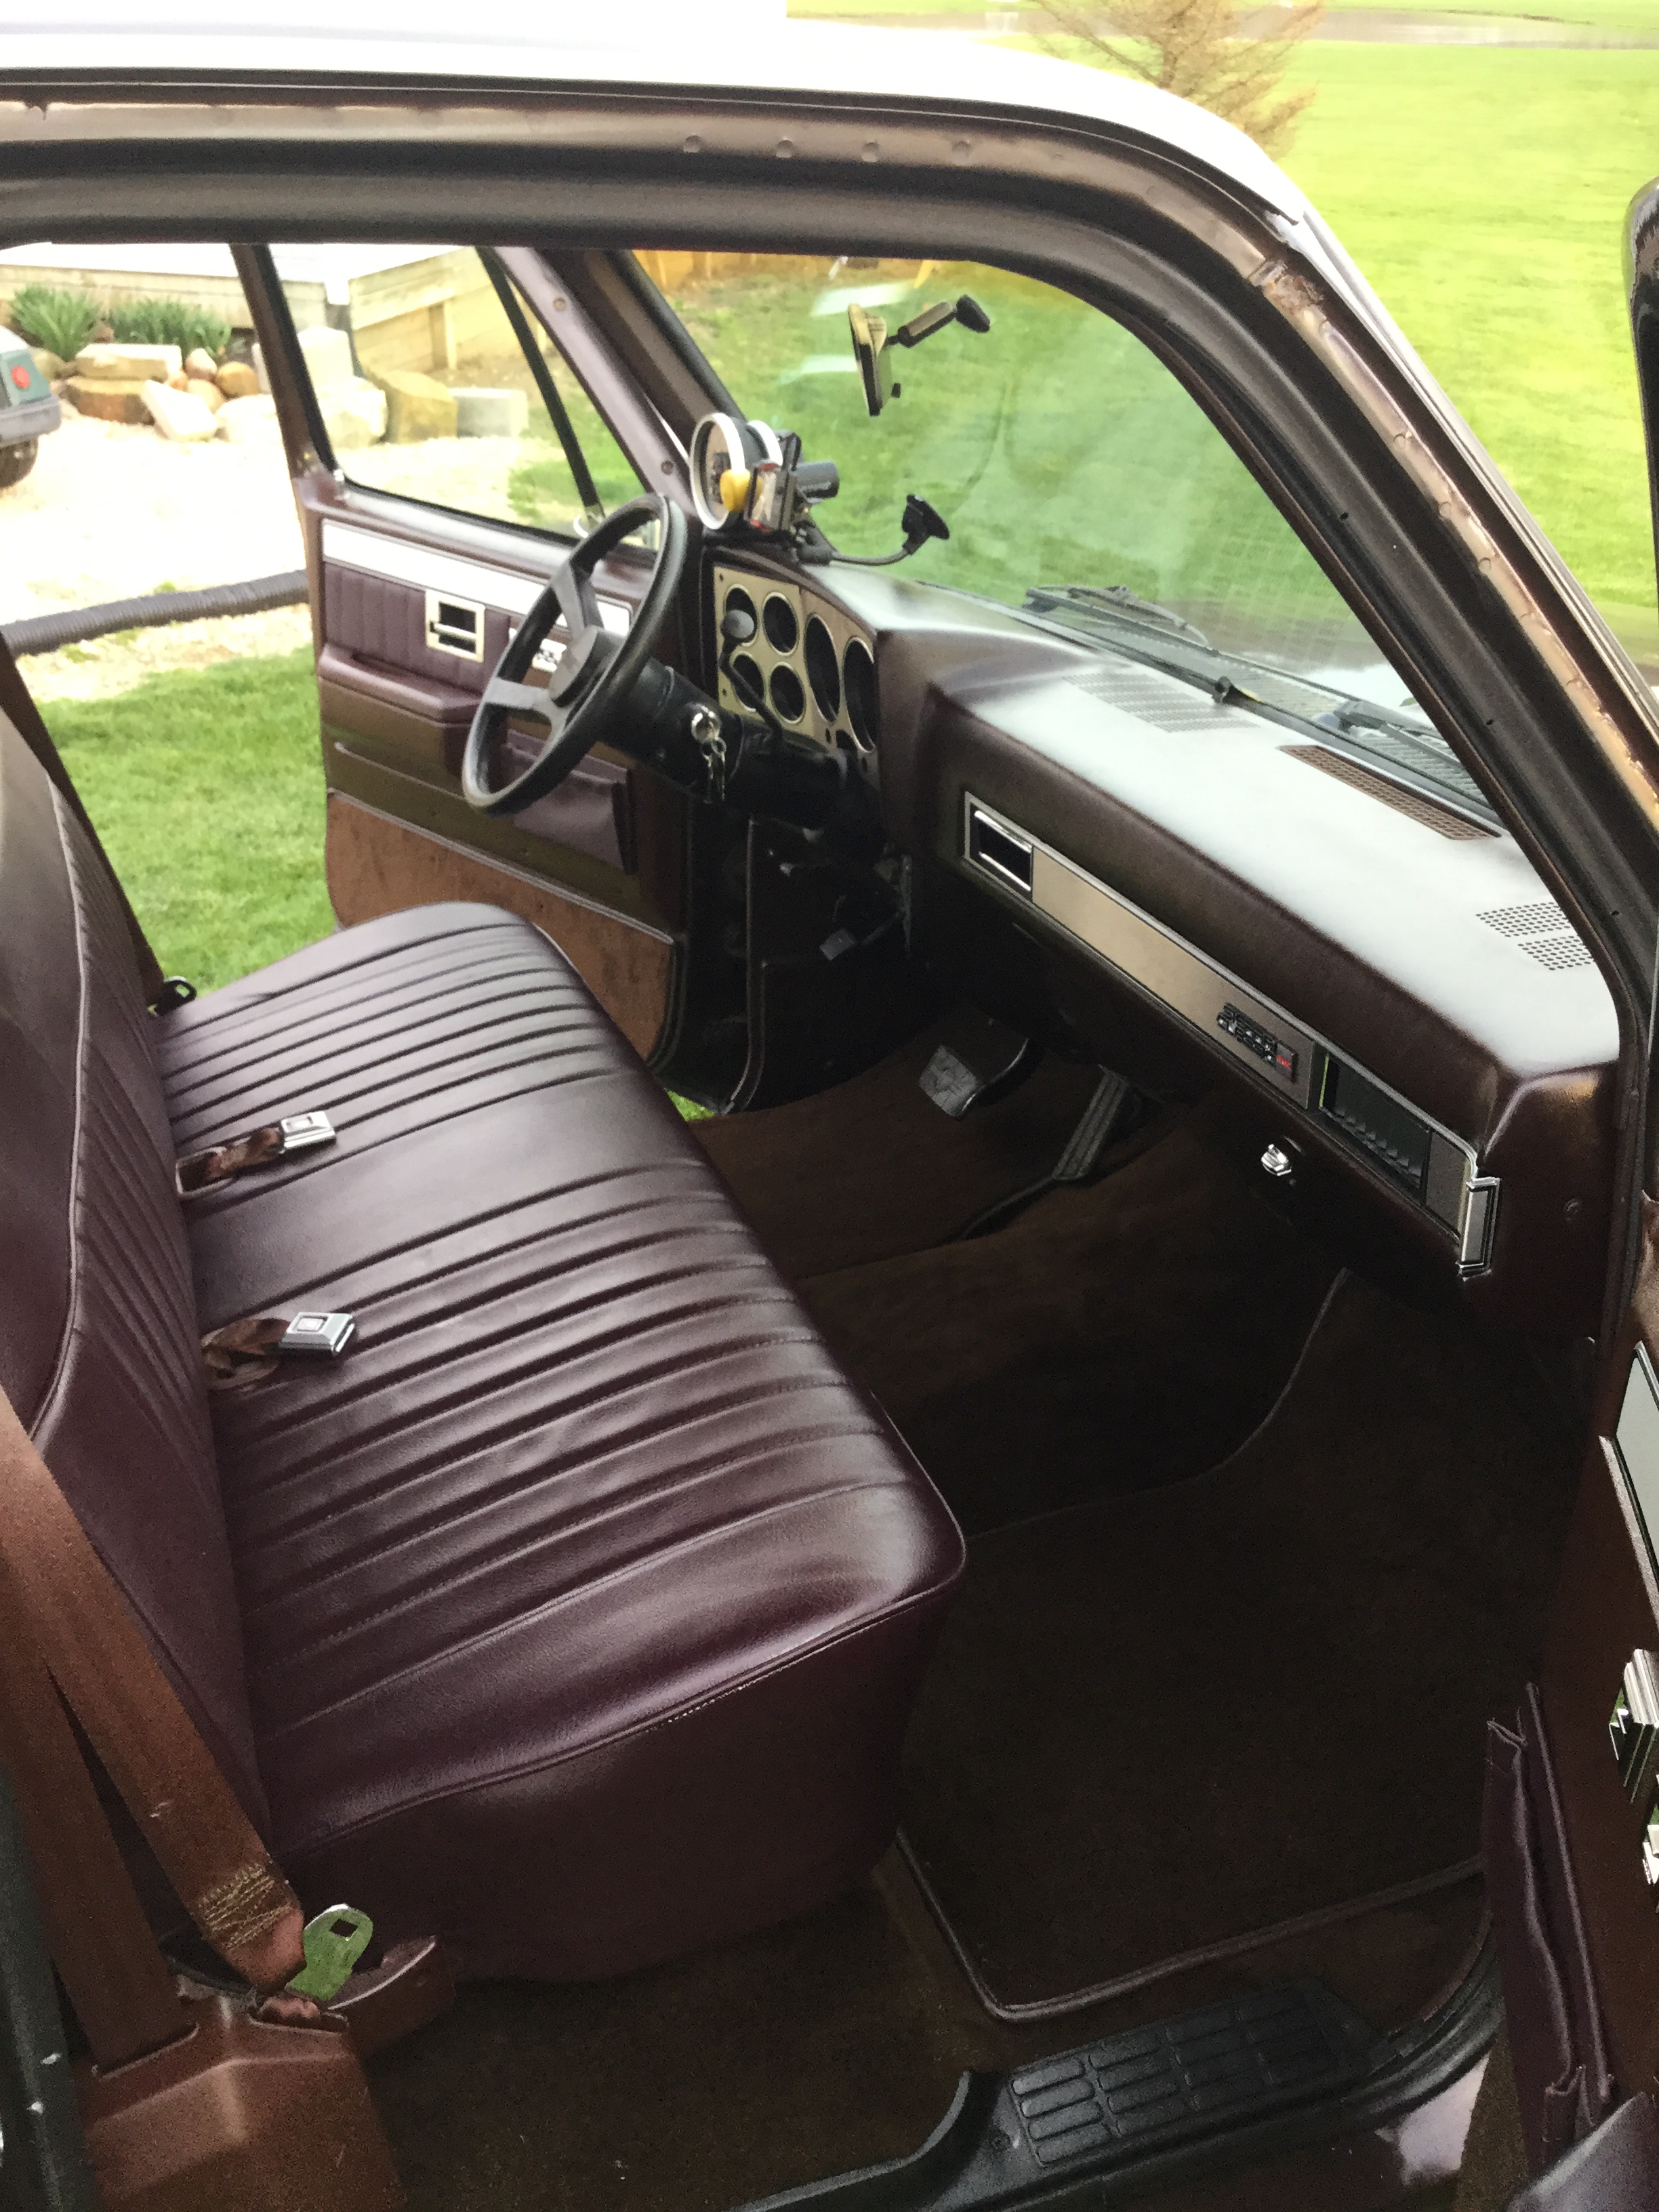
[274, 245, 639, 535]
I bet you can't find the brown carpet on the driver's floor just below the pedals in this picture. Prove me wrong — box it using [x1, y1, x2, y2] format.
[693, 1017, 1099, 1281]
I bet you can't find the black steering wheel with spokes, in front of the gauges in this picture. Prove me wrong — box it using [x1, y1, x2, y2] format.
[460, 491, 686, 814]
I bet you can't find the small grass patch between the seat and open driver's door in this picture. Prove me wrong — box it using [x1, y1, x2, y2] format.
[46, 651, 334, 991]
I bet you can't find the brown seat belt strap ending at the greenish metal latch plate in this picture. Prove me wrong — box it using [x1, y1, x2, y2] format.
[0, 1391, 305, 1991]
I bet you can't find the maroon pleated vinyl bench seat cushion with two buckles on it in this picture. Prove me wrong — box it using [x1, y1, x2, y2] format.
[159, 907, 962, 1978]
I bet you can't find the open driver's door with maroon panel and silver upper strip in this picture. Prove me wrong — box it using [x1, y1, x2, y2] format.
[243, 252, 688, 1053]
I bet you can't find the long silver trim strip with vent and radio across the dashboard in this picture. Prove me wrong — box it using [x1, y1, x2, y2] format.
[960, 790, 1500, 1279]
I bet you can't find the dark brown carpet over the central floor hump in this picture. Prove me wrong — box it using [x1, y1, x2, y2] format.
[803, 1108, 1336, 1535]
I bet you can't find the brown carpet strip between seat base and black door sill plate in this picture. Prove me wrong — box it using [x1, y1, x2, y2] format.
[369, 1883, 964, 2212]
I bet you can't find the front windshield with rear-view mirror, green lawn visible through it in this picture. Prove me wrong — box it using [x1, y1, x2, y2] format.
[637, 252, 1416, 719]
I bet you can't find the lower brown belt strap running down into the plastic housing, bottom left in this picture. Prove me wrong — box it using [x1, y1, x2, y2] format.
[0, 1564, 188, 2068]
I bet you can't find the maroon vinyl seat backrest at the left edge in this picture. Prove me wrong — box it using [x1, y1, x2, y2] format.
[0, 721, 266, 1818]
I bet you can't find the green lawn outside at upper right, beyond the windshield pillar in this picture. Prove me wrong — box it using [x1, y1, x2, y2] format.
[1285, 43, 1659, 621]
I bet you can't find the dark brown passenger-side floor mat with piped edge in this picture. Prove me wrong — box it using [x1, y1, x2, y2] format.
[905, 1279, 1573, 2004]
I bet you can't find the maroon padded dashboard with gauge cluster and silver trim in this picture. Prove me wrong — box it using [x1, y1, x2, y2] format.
[712, 555, 1619, 1334]
